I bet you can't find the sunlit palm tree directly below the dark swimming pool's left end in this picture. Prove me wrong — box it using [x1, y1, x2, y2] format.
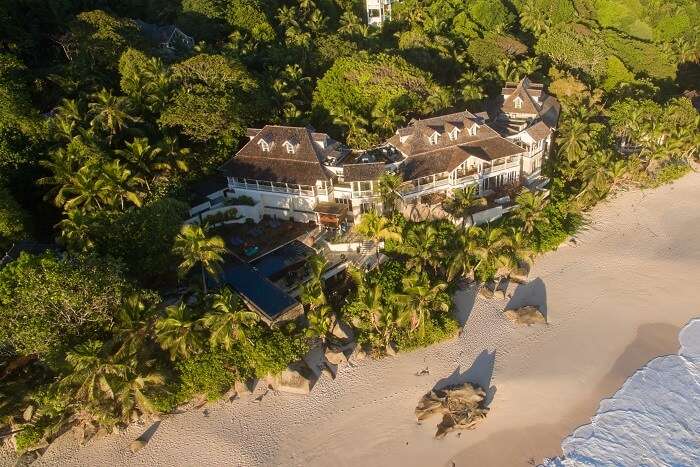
[201, 287, 258, 351]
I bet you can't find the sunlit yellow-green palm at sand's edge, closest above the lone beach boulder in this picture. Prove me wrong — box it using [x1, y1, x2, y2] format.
[394, 273, 451, 337]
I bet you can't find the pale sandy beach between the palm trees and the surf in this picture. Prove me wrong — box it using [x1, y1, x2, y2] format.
[5, 173, 700, 467]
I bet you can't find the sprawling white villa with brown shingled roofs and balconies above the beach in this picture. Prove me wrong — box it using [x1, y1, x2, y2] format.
[198, 78, 559, 227]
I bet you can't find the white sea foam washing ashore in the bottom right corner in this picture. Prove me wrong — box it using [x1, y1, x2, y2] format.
[544, 318, 700, 467]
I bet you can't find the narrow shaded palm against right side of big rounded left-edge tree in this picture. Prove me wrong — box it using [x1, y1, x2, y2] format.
[112, 294, 151, 358]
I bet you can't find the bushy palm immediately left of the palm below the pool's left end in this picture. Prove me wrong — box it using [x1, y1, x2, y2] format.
[155, 302, 199, 360]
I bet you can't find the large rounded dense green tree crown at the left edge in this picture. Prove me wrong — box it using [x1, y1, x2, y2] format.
[0, 253, 133, 358]
